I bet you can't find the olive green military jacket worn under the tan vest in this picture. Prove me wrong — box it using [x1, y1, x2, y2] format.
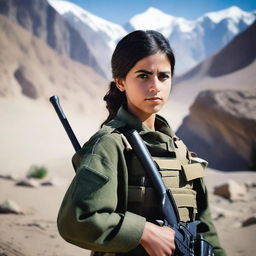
[57, 107, 225, 256]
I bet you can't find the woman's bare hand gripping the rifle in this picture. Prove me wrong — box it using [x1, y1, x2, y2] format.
[140, 222, 175, 256]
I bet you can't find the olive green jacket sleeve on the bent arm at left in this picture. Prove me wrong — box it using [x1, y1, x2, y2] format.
[57, 136, 146, 252]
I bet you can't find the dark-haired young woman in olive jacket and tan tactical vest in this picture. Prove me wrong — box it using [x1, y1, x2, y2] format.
[58, 31, 225, 256]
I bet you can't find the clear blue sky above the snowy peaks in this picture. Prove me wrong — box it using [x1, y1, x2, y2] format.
[69, 0, 256, 25]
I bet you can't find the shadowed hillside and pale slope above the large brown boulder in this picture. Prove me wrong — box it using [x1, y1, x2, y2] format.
[164, 20, 256, 130]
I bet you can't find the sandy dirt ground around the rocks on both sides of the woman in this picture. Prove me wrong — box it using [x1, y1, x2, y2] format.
[0, 169, 256, 256]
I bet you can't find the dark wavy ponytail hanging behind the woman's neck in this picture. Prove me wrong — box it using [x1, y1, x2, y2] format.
[101, 81, 126, 127]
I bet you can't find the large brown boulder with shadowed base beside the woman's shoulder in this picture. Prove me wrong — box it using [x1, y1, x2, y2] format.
[177, 90, 256, 170]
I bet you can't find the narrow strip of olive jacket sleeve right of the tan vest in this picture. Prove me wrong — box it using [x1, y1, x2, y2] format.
[195, 179, 226, 256]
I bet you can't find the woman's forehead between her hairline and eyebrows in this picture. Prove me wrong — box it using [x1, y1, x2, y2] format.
[131, 52, 171, 71]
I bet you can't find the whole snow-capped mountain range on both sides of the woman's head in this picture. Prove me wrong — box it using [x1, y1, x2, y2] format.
[48, 0, 256, 77]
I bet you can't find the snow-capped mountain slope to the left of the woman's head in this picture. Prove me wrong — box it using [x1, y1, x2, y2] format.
[48, 0, 127, 76]
